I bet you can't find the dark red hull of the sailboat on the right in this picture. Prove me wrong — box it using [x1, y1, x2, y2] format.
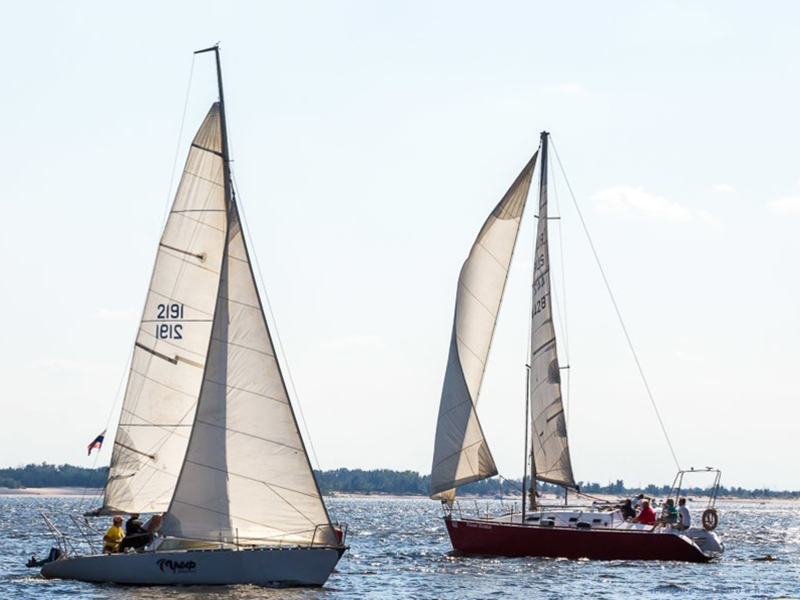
[445, 518, 711, 562]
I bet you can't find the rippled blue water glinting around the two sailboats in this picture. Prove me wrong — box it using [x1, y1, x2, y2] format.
[0, 497, 800, 600]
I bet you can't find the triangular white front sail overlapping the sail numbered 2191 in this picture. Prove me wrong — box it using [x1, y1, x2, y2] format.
[161, 203, 337, 546]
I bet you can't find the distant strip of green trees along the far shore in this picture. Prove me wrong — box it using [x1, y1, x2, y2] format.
[0, 463, 800, 498]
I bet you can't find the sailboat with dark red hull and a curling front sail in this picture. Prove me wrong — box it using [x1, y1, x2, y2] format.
[431, 132, 723, 562]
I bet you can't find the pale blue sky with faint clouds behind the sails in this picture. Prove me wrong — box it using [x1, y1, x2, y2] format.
[0, 1, 800, 490]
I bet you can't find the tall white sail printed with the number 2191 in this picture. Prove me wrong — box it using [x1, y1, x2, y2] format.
[98, 104, 226, 514]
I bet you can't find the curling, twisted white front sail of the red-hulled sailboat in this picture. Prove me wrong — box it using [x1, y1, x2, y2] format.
[431, 154, 537, 502]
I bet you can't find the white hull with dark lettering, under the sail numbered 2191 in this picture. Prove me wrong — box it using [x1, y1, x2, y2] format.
[42, 548, 344, 587]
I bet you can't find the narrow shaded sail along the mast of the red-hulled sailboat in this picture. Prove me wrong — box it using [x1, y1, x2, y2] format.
[529, 133, 576, 488]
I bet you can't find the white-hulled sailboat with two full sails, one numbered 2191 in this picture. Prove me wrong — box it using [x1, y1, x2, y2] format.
[41, 46, 346, 586]
